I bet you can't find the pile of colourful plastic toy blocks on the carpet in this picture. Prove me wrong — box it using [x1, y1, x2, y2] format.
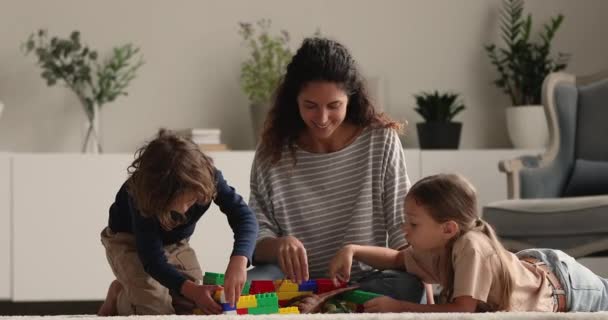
[195, 272, 380, 314]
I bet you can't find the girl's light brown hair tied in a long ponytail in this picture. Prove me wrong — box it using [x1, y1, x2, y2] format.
[406, 174, 513, 310]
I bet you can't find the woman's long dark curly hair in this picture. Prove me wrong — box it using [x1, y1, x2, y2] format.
[260, 38, 401, 163]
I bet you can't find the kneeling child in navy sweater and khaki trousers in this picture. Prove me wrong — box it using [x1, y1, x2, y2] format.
[99, 130, 258, 316]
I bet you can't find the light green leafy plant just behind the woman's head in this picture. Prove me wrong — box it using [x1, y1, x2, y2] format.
[239, 19, 293, 104]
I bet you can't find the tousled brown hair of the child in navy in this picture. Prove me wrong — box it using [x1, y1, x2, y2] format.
[127, 129, 216, 230]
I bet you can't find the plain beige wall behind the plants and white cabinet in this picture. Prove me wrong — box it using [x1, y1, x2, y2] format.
[0, 0, 608, 152]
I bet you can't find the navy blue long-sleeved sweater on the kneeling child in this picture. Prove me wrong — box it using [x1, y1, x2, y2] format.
[108, 169, 258, 293]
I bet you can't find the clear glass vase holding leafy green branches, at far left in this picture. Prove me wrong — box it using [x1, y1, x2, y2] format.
[24, 30, 143, 153]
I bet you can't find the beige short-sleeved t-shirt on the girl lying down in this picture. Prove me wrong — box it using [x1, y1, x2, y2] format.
[405, 231, 554, 311]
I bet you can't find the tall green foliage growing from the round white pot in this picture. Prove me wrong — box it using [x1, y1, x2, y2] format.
[485, 0, 570, 106]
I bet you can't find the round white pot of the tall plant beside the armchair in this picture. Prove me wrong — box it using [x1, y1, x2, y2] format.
[506, 105, 549, 149]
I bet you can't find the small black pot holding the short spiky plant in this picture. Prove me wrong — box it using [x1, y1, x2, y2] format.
[416, 122, 462, 149]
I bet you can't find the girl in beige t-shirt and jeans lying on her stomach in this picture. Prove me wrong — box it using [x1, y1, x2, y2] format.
[329, 174, 608, 312]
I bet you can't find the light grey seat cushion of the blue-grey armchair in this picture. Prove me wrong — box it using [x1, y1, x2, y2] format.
[483, 196, 608, 257]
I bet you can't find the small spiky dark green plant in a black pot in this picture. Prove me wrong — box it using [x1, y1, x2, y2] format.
[414, 91, 465, 149]
